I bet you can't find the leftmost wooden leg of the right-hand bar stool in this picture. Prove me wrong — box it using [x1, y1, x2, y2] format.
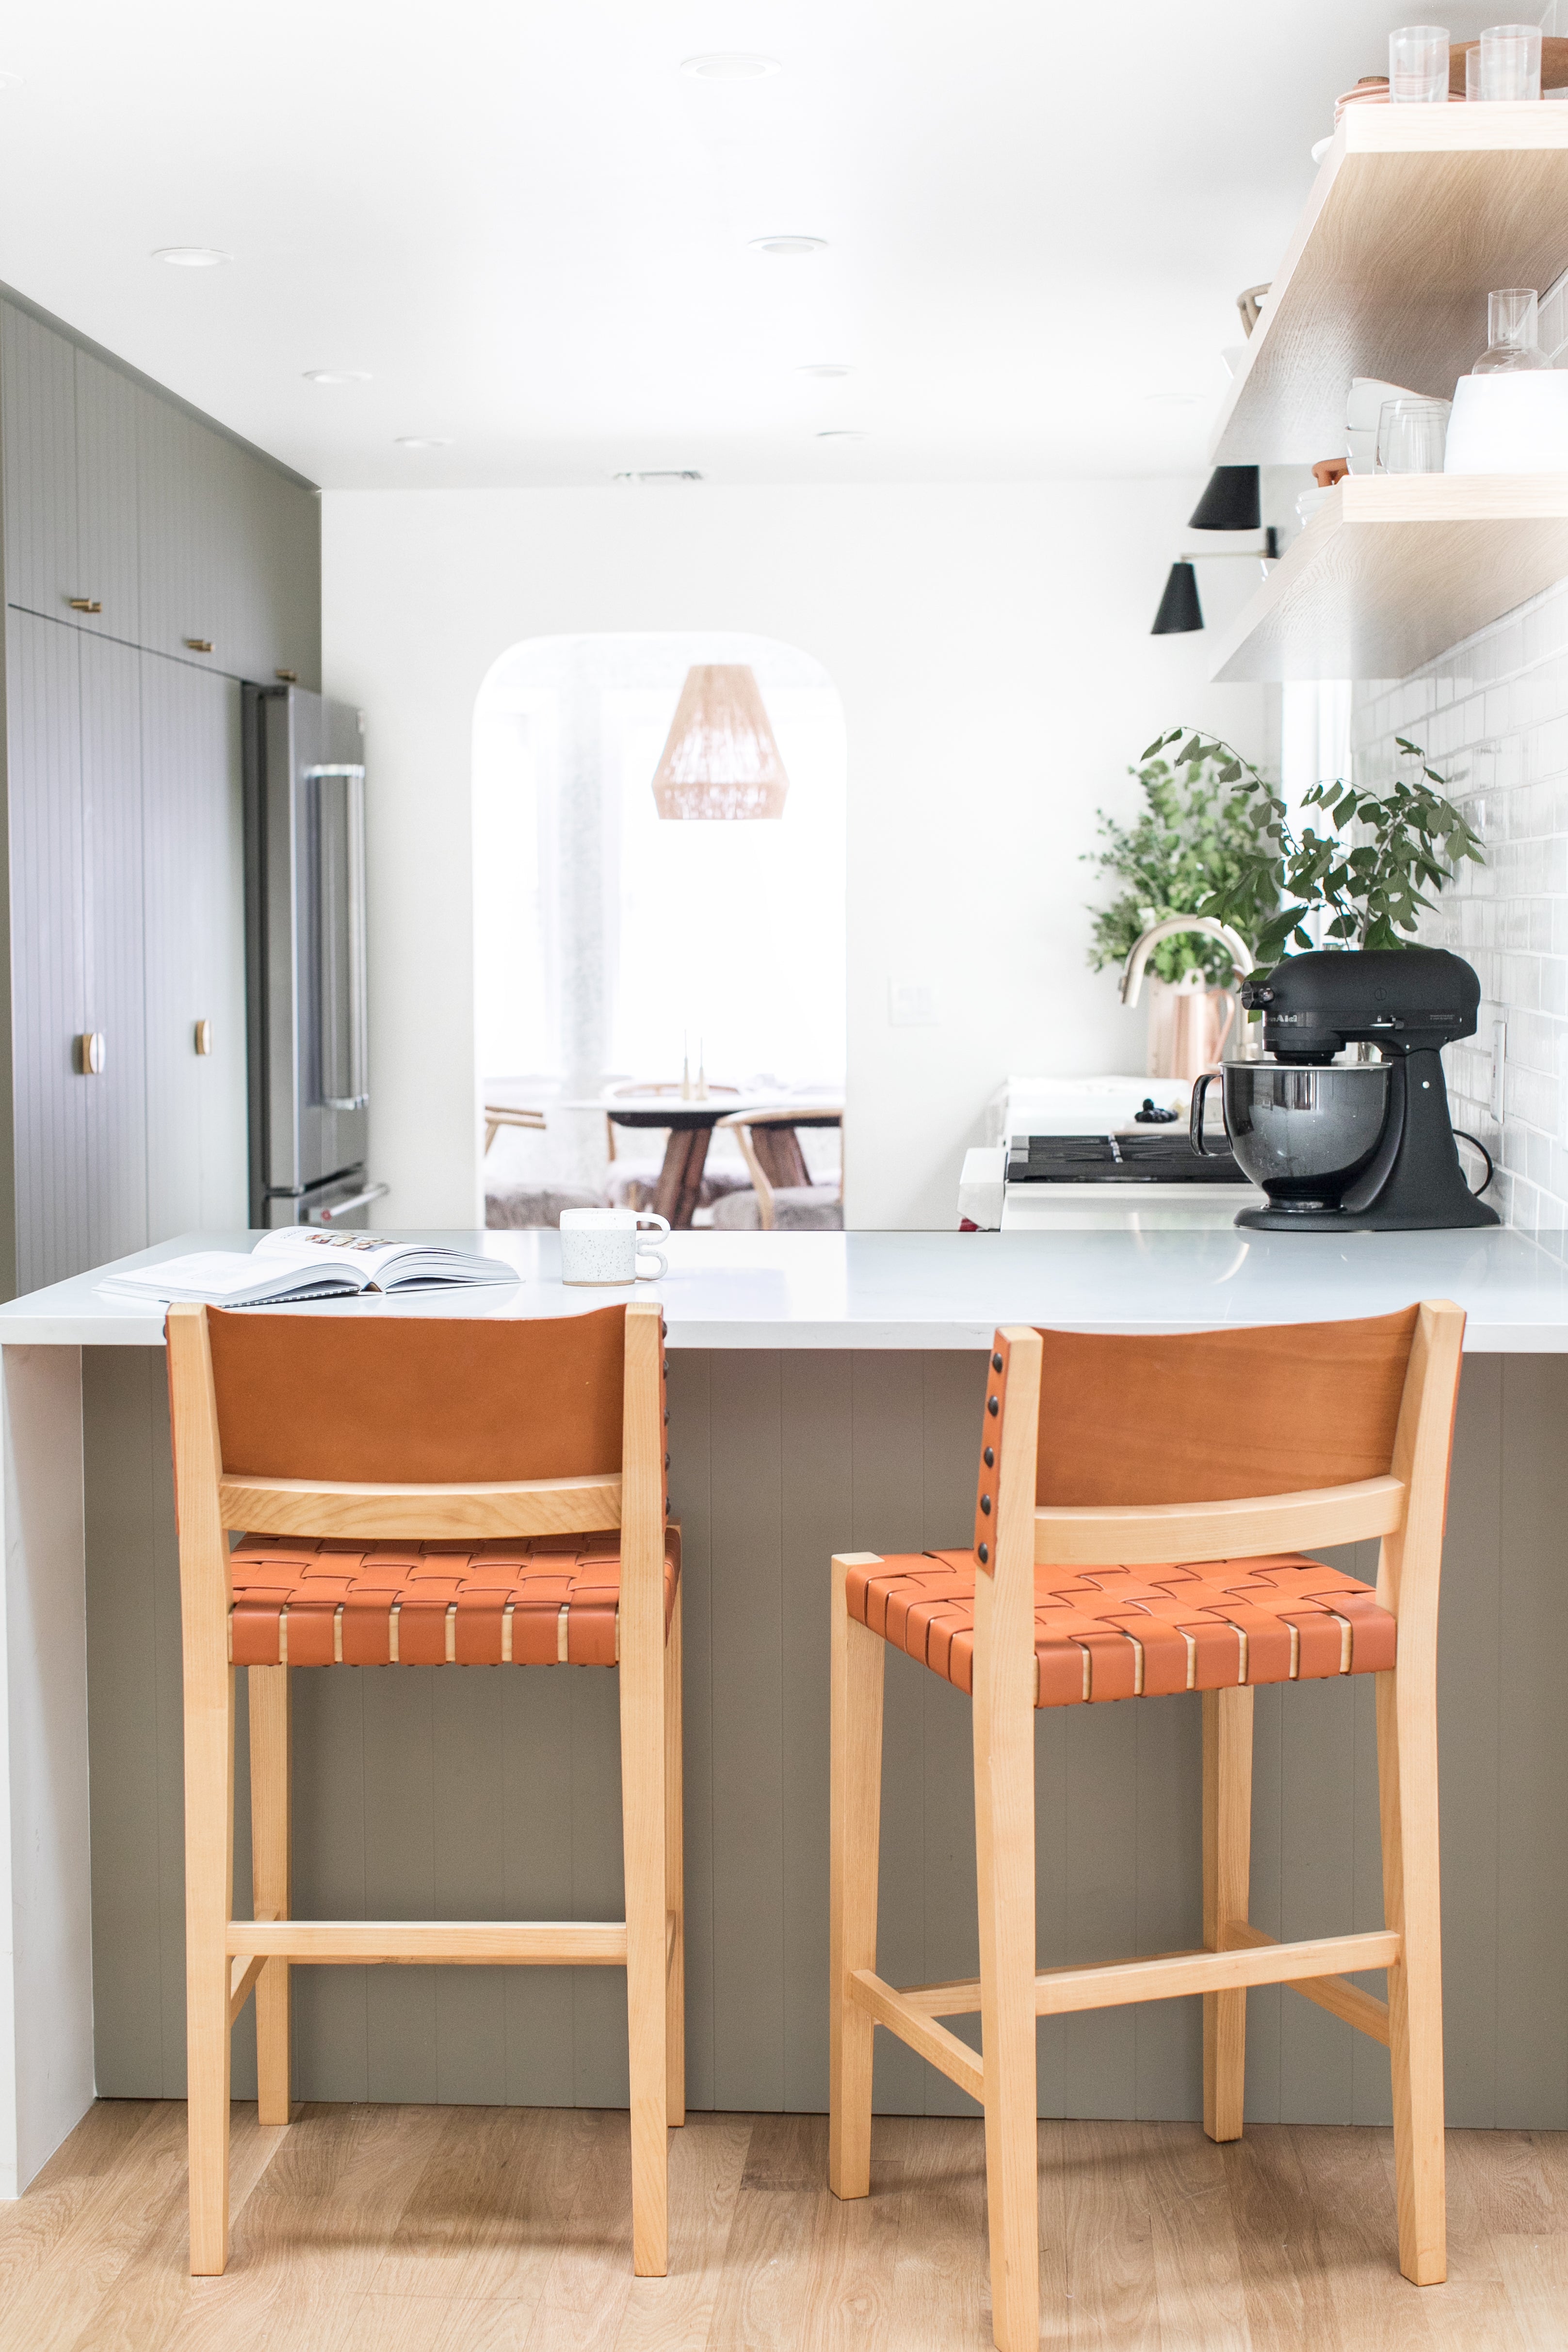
[827, 1559, 886, 2197]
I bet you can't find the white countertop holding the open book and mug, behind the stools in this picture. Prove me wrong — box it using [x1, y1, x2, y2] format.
[0, 1228, 1568, 1355]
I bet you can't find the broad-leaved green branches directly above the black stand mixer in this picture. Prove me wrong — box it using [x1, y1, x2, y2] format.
[1145, 727, 1486, 964]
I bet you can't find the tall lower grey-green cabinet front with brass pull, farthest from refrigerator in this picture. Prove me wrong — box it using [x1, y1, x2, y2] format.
[7, 612, 148, 1291]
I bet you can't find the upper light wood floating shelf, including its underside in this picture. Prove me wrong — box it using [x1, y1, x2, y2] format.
[1211, 101, 1568, 466]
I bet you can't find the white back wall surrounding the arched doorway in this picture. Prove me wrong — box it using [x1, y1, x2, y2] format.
[322, 480, 1262, 1228]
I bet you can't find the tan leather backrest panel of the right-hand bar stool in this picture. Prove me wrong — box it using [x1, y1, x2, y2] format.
[1035, 1308, 1418, 1508]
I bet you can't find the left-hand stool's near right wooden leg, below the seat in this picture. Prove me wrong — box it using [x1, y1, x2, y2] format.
[621, 1576, 670, 2279]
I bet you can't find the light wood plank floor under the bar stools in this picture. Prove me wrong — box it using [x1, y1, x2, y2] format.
[0, 2100, 1568, 2352]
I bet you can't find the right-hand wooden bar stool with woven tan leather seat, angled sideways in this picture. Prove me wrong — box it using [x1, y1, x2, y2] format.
[830, 1300, 1465, 2352]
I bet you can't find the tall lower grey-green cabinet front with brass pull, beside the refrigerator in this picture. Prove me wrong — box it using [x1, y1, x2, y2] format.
[141, 654, 247, 1242]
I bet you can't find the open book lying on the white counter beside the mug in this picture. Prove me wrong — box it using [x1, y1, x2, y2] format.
[99, 1225, 517, 1308]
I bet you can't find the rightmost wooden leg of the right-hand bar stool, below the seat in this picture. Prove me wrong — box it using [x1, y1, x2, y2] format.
[1377, 1655, 1448, 2286]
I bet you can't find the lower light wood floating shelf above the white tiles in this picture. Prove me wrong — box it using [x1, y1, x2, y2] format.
[1213, 472, 1568, 682]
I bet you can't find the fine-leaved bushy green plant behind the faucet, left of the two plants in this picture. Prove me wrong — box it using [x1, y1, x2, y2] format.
[1084, 729, 1279, 988]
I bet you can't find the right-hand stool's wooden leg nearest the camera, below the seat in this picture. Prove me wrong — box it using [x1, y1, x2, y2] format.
[973, 1576, 1039, 2352]
